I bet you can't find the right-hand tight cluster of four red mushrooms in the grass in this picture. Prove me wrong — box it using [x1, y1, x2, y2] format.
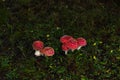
[60, 35, 87, 54]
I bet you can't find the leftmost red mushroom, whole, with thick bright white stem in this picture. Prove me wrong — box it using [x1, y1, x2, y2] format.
[32, 40, 44, 56]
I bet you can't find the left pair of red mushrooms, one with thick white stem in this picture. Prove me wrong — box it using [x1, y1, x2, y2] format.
[32, 40, 55, 56]
